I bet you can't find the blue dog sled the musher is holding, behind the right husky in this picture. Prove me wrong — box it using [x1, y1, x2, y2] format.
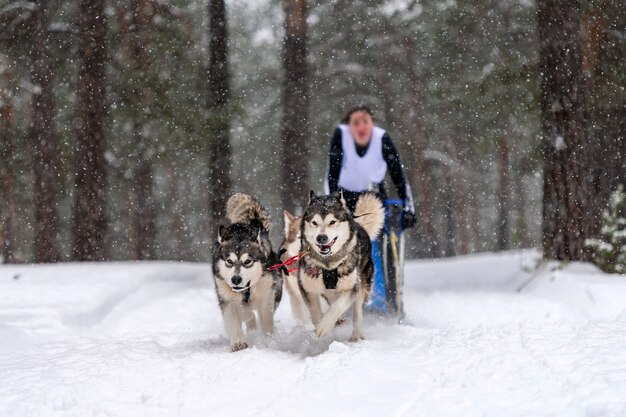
[367, 200, 404, 321]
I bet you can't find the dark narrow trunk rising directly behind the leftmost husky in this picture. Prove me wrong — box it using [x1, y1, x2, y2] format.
[207, 0, 231, 225]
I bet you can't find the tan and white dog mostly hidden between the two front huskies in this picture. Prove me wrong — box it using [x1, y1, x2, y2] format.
[280, 211, 311, 324]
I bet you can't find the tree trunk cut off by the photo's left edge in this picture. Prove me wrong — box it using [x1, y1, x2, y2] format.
[0, 102, 17, 263]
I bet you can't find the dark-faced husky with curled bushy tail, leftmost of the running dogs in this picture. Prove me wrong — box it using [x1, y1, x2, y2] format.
[213, 193, 282, 352]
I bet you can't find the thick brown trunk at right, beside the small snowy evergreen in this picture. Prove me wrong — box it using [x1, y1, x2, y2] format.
[537, 0, 592, 260]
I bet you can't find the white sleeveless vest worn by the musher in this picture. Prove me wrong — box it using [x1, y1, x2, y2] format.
[339, 124, 387, 192]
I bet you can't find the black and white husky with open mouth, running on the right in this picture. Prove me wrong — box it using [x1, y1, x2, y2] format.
[298, 191, 385, 341]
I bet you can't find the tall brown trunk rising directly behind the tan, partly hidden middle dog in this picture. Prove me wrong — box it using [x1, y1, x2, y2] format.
[281, 0, 309, 213]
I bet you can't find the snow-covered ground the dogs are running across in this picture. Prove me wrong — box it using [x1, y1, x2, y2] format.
[0, 252, 626, 417]
